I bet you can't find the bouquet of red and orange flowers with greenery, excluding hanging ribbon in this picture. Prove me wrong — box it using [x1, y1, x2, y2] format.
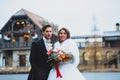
[47, 49, 72, 67]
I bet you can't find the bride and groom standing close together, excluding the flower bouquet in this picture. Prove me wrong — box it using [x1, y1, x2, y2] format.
[28, 25, 85, 80]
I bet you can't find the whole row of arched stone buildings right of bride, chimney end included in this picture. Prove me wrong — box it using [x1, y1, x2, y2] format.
[71, 24, 120, 70]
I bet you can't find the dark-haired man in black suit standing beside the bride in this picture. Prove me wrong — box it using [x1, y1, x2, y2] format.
[28, 25, 52, 80]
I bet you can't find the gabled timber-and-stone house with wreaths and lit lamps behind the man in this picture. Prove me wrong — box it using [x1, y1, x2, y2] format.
[0, 9, 58, 72]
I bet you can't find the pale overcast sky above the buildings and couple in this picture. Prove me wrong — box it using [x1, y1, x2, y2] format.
[0, 0, 120, 36]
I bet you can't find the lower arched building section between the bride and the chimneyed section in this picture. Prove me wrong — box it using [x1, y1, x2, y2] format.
[71, 35, 103, 70]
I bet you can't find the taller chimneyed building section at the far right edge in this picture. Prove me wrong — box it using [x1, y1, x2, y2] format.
[103, 23, 120, 68]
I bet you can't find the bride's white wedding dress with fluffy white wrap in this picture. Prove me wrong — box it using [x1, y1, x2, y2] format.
[48, 39, 85, 80]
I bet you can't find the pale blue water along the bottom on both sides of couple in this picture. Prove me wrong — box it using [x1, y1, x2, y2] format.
[0, 72, 120, 80]
